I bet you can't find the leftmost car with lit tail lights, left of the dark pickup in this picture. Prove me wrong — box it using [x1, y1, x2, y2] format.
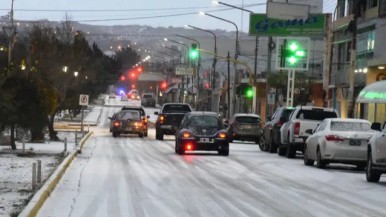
[109, 110, 144, 138]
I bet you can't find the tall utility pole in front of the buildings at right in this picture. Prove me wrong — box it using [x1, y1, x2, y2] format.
[347, 1, 361, 118]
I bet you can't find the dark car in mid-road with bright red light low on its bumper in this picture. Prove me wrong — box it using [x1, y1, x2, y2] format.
[175, 112, 229, 156]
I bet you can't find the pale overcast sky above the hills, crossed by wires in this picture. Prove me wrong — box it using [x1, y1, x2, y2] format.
[0, 0, 336, 32]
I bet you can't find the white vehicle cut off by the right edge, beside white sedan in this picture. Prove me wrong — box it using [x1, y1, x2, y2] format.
[366, 123, 386, 182]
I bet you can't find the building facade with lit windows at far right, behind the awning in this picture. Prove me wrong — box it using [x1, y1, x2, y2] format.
[329, 0, 386, 123]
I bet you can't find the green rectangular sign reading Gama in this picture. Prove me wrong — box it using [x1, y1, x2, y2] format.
[249, 14, 326, 36]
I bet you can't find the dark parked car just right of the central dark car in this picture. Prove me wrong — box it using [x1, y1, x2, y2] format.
[227, 113, 263, 144]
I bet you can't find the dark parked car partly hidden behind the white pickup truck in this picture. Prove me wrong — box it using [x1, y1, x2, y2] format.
[261, 107, 294, 153]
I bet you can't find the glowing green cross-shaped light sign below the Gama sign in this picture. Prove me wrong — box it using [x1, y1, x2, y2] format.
[282, 40, 307, 67]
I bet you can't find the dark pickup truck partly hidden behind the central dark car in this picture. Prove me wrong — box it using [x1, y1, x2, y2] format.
[154, 103, 192, 140]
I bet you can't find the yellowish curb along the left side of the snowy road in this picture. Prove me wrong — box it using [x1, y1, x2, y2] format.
[19, 132, 93, 217]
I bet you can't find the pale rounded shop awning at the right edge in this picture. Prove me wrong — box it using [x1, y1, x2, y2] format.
[356, 80, 386, 103]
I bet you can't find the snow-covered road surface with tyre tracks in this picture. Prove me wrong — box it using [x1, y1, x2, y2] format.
[38, 107, 386, 217]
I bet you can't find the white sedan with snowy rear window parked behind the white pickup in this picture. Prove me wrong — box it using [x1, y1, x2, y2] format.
[304, 118, 376, 170]
